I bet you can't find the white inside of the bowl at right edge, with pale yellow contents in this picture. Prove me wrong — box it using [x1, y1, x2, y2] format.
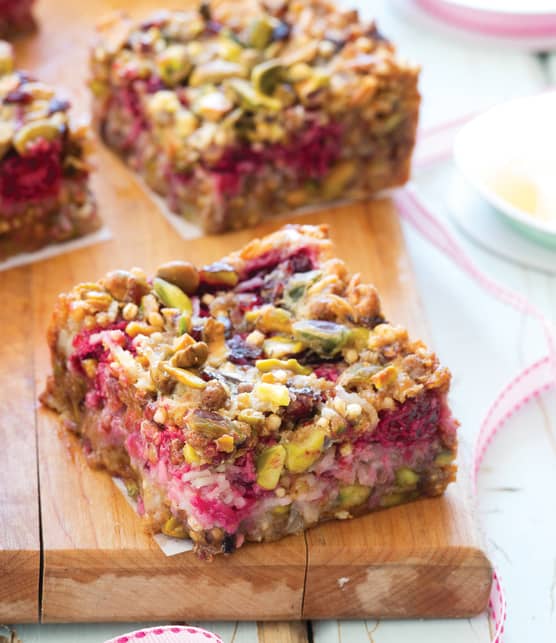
[454, 92, 556, 248]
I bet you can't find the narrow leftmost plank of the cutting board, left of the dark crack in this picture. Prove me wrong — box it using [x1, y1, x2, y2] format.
[0, 269, 40, 623]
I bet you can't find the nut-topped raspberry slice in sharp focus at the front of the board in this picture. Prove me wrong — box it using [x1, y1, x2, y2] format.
[42, 226, 457, 557]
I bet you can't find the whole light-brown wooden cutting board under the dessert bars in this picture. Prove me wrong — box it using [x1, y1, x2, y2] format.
[0, 0, 491, 622]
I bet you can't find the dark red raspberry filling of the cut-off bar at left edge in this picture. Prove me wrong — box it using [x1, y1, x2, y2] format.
[0, 139, 62, 205]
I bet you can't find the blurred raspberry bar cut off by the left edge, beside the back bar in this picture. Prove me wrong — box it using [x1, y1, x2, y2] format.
[0, 41, 100, 261]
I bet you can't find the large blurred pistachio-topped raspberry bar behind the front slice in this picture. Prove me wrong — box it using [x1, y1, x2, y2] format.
[90, 0, 420, 233]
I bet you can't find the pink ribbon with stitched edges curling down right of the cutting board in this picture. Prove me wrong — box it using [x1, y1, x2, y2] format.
[394, 186, 556, 643]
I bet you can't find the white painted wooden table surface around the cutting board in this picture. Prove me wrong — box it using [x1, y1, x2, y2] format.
[5, 0, 556, 643]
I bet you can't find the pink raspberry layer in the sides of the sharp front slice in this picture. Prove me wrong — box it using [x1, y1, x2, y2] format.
[70, 322, 457, 534]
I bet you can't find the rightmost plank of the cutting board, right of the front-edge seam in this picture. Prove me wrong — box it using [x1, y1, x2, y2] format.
[303, 202, 491, 619]
